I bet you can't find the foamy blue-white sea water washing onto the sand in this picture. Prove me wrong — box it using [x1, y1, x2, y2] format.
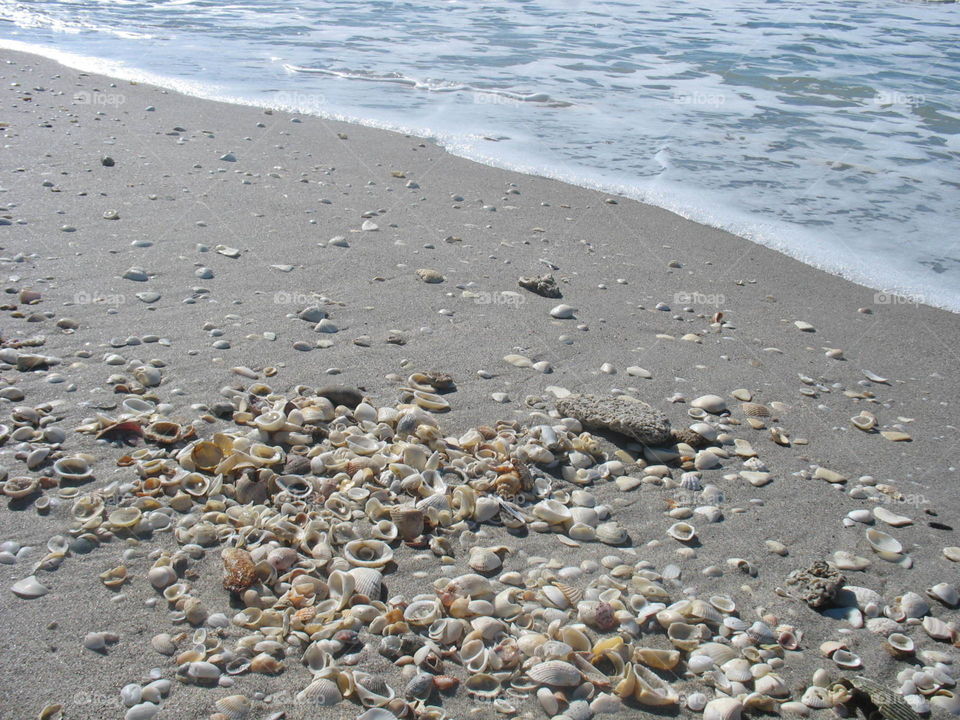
[0, 0, 960, 311]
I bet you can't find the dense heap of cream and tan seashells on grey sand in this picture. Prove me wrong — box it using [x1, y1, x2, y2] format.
[3, 377, 960, 720]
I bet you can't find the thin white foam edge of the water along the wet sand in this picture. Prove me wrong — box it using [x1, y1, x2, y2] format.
[0, 40, 960, 314]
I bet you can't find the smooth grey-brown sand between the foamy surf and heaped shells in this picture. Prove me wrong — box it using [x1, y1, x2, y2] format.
[0, 51, 960, 720]
